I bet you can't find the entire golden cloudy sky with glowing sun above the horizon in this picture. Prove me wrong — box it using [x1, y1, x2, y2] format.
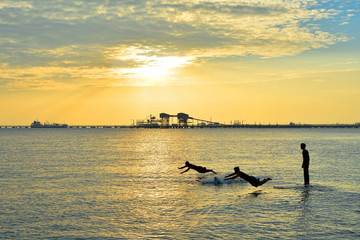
[0, 0, 360, 125]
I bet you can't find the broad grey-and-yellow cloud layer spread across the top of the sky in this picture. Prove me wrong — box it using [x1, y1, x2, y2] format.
[0, 0, 351, 88]
